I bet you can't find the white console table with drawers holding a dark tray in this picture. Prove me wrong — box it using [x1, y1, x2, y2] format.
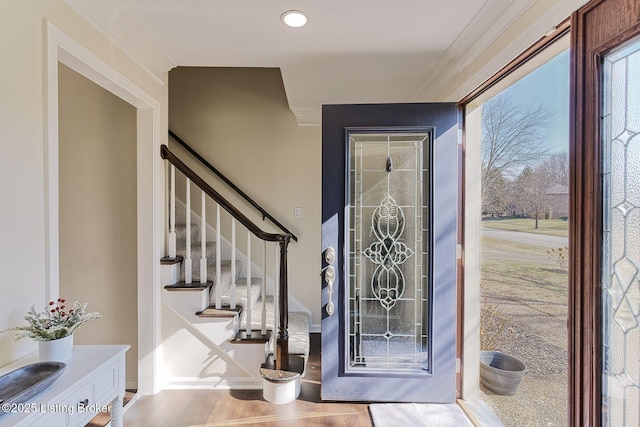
[0, 345, 130, 427]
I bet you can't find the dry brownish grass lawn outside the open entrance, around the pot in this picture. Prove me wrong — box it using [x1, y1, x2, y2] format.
[481, 234, 568, 427]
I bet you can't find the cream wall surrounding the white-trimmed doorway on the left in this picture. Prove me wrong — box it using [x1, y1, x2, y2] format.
[0, 0, 167, 366]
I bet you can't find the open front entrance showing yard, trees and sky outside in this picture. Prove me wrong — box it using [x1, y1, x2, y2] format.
[465, 31, 570, 426]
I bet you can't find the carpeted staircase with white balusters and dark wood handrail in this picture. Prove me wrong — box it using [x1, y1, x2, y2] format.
[160, 134, 310, 403]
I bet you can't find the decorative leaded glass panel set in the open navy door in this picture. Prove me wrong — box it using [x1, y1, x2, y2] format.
[347, 132, 430, 374]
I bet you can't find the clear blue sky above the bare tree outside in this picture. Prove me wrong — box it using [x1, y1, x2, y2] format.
[496, 50, 569, 152]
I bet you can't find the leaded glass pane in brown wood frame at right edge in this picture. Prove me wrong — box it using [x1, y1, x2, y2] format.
[602, 35, 640, 427]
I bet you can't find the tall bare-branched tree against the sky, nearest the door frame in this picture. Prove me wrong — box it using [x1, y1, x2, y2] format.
[481, 96, 553, 211]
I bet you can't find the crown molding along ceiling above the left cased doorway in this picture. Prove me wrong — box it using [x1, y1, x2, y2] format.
[65, 0, 177, 85]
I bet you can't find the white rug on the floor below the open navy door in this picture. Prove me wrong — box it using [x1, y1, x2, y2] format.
[369, 403, 473, 427]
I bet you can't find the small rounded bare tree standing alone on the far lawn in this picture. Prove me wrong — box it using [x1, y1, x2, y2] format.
[513, 166, 553, 229]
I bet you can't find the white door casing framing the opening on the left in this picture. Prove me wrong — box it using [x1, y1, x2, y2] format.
[45, 23, 163, 393]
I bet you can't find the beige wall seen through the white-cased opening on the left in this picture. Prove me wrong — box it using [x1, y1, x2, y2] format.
[58, 65, 138, 383]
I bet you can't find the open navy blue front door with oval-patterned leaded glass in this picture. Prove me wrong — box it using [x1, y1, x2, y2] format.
[322, 103, 460, 403]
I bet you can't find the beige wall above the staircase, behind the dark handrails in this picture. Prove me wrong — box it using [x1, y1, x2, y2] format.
[169, 68, 321, 325]
